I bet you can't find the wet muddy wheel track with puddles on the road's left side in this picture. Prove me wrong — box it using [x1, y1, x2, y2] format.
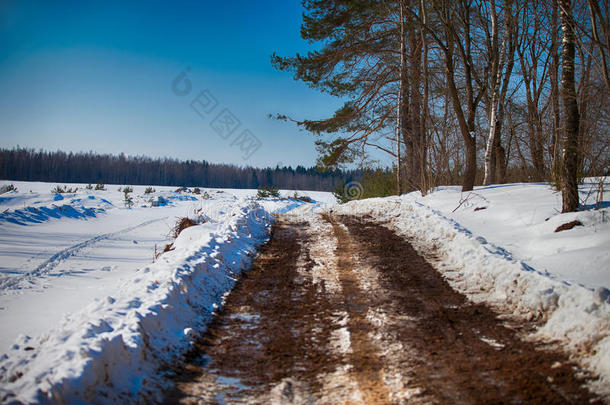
[167, 220, 338, 404]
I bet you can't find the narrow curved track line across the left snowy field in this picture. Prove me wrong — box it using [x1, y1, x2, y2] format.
[0, 216, 168, 291]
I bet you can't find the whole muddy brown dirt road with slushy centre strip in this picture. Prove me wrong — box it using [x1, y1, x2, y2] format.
[167, 214, 597, 404]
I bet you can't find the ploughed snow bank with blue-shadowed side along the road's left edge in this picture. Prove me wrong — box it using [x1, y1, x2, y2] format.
[0, 199, 272, 403]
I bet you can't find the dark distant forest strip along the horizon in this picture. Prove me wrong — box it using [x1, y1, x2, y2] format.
[0, 148, 362, 191]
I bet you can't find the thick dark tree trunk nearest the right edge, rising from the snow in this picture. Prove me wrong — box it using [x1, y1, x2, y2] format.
[559, 0, 580, 212]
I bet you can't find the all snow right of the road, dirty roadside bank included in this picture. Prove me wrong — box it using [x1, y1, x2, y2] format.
[332, 178, 610, 395]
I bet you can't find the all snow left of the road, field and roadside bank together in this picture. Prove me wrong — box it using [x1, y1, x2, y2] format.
[0, 182, 333, 402]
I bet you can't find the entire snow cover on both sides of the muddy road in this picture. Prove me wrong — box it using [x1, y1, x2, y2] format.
[0, 179, 610, 403]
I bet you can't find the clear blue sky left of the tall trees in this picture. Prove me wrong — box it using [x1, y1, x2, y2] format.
[0, 0, 341, 166]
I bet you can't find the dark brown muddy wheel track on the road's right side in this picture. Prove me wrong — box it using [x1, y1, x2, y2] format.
[340, 216, 601, 404]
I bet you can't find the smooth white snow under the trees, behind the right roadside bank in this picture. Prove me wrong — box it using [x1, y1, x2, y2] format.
[414, 179, 610, 288]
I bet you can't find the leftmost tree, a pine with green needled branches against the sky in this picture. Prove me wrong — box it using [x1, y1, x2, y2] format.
[272, 0, 407, 174]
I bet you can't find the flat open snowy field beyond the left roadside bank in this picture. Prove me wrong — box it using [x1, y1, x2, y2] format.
[0, 181, 333, 357]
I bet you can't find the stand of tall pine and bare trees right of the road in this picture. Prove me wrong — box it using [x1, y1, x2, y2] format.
[271, 0, 610, 212]
